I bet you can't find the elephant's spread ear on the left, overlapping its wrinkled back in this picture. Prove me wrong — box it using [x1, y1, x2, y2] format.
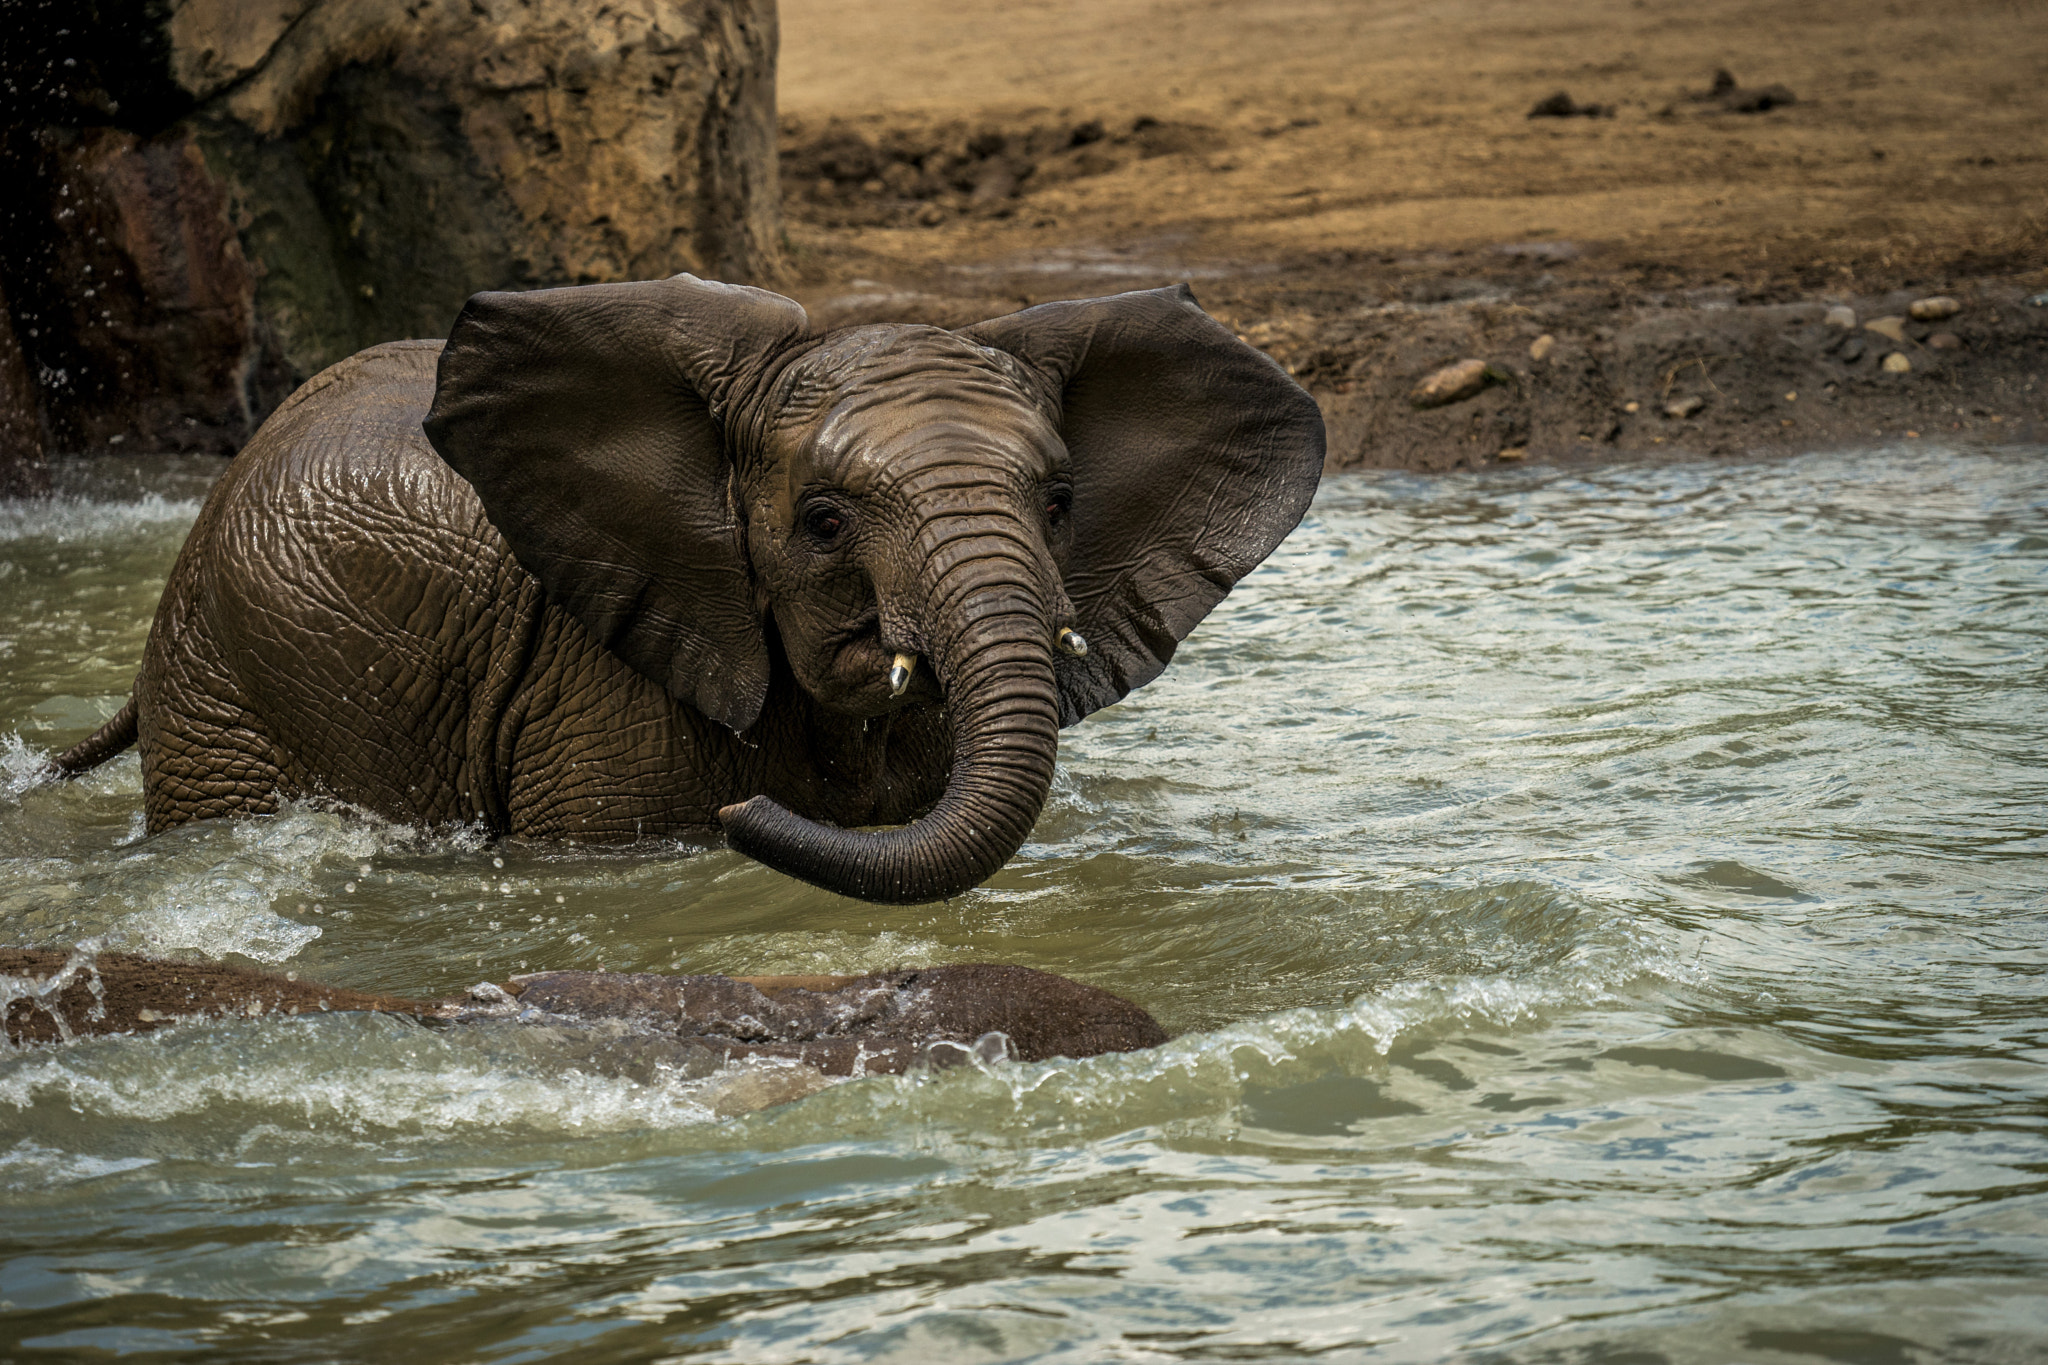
[426, 274, 805, 731]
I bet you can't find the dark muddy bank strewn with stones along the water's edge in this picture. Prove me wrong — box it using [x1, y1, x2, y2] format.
[1247, 287, 2048, 471]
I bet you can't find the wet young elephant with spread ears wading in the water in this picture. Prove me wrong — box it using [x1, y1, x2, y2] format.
[59, 276, 1323, 902]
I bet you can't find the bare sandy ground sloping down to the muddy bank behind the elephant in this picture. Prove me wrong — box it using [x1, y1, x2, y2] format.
[780, 0, 2048, 467]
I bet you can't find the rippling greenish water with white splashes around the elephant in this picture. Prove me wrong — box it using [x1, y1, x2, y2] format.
[0, 448, 2048, 1365]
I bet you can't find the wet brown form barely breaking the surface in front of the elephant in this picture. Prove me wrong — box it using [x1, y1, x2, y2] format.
[0, 948, 1165, 1076]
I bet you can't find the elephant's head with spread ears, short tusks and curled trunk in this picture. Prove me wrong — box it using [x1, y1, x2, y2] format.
[426, 276, 1323, 902]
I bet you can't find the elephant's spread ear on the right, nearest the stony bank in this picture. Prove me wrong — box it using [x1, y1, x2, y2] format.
[963, 284, 1323, 724]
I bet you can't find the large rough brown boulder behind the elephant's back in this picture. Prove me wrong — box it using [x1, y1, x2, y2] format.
[0, 0, 780, 471]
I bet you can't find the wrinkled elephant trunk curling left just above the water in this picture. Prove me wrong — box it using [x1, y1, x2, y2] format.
[719, 534, 1059, 905]
